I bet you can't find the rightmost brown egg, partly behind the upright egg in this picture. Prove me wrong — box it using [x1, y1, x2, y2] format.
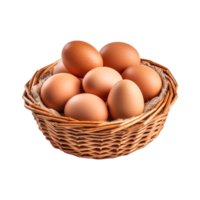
[122, 65, 162, 102]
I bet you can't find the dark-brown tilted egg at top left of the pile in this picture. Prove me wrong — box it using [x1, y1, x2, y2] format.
[61, 40, 103, 78]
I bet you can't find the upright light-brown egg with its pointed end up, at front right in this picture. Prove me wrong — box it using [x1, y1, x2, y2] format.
[107, 80, 144, 120]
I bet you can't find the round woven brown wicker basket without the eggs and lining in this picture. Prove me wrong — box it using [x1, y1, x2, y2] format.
[20, 58, 180, 160]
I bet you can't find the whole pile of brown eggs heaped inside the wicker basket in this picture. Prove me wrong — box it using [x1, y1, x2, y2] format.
[40, 40, 162, 121]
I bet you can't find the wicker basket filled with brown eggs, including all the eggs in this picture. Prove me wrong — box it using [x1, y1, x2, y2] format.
[21, 40, 180, 160]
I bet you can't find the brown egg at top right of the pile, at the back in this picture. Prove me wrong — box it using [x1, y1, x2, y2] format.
[99, 41, 140, 74]
